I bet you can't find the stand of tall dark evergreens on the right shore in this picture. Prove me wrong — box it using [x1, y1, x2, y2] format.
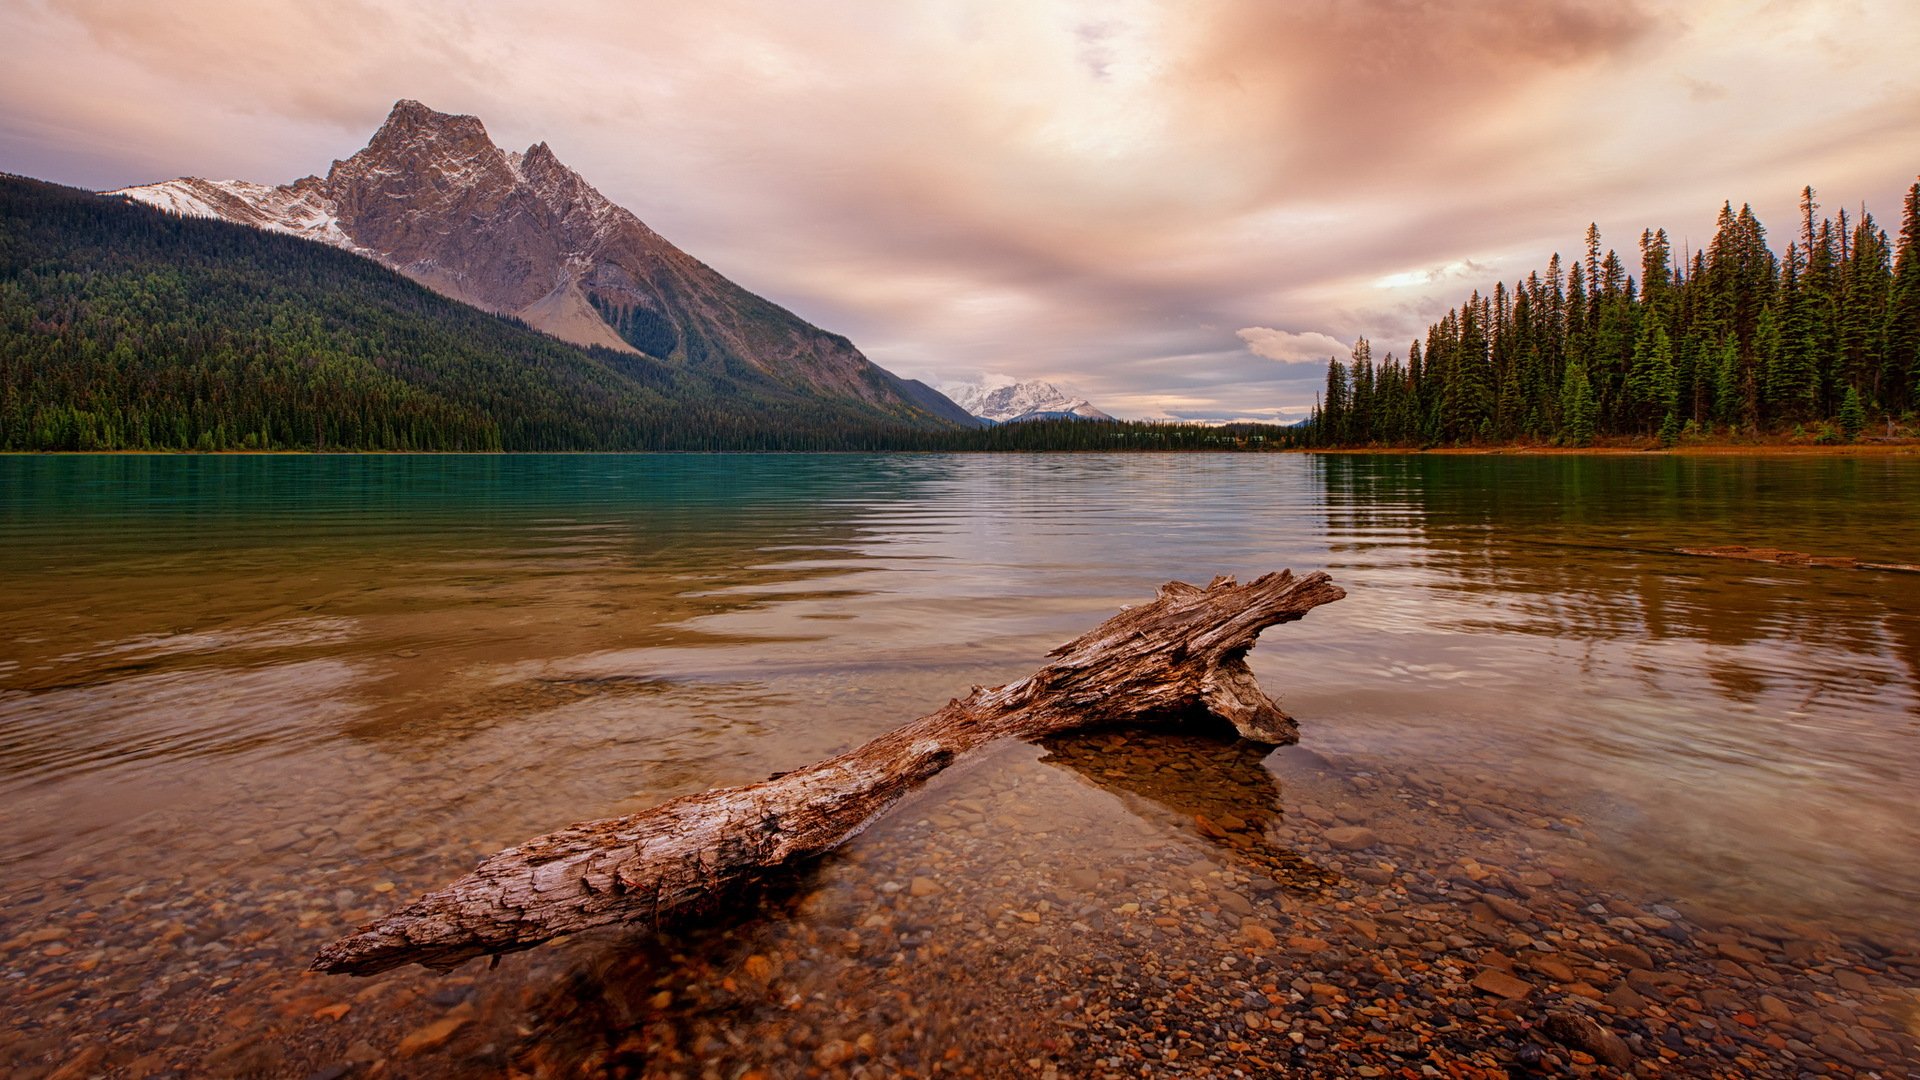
[1292, 183, 1920, 446]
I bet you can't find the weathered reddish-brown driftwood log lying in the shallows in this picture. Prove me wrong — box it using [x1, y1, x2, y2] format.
[313, 571, 1346, 974]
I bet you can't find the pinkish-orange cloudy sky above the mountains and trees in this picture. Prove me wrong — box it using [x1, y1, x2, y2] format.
[0, 0, 1920, 421]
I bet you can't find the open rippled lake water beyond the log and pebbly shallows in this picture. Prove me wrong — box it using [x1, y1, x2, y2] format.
[0, 447, 1920, 1068]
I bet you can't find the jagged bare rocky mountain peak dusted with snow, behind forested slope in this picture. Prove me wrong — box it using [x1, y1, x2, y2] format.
[109, 100, 975, 427]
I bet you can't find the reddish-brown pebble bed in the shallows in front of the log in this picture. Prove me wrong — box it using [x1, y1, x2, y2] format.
[0, 734, 1920, 1080]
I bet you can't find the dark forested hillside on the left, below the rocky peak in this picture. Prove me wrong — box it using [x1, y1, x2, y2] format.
[0, 173, 967, 452]
